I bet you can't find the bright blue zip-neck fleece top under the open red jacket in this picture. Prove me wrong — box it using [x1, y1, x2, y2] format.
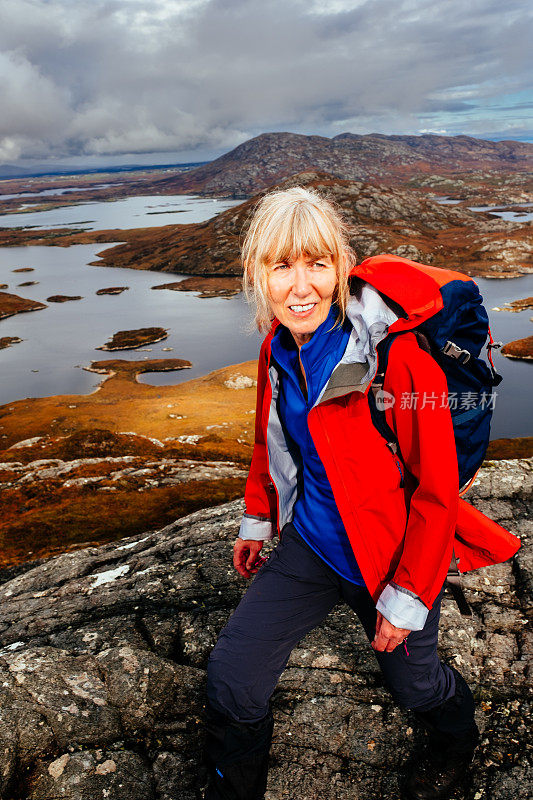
[271, 304, 364, 586]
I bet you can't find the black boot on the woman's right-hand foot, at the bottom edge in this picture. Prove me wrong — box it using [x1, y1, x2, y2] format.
[402, 752, 474, 800]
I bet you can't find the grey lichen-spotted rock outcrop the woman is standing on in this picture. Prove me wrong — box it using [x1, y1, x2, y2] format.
[0, 460, 533, 800]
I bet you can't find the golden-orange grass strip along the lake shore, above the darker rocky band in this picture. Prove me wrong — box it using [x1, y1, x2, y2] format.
[0, 359, 257, 461]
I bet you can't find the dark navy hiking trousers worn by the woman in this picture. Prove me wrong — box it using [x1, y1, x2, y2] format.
[206, 523, 474, 800]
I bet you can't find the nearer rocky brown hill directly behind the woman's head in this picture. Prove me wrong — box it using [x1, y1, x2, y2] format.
[89, 172, 533, 277]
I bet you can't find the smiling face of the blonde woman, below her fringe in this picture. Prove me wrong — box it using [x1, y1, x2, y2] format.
[267, 254, 337, 347]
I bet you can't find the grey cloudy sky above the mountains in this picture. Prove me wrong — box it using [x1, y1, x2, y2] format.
[0, 0, 533, 166]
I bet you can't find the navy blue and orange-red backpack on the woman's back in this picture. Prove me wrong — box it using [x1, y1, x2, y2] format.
[364, 257, 502, 493]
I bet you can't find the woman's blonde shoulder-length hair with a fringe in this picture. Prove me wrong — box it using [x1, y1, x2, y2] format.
[242, 186, 356, 332]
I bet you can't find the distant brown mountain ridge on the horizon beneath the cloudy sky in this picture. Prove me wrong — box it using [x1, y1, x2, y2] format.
[145, 133, 533, 198]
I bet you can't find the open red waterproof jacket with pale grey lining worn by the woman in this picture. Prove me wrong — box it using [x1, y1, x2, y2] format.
[240, 256, 520, 608]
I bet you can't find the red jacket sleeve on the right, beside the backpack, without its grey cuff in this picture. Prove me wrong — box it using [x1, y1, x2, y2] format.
[383, 333, 459, 608]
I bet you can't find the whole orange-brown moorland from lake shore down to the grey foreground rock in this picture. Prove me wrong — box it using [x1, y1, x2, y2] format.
[0, 359, 533, 566]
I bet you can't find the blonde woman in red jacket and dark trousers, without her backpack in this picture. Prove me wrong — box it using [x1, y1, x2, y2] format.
[205, 187, 516, 800]
